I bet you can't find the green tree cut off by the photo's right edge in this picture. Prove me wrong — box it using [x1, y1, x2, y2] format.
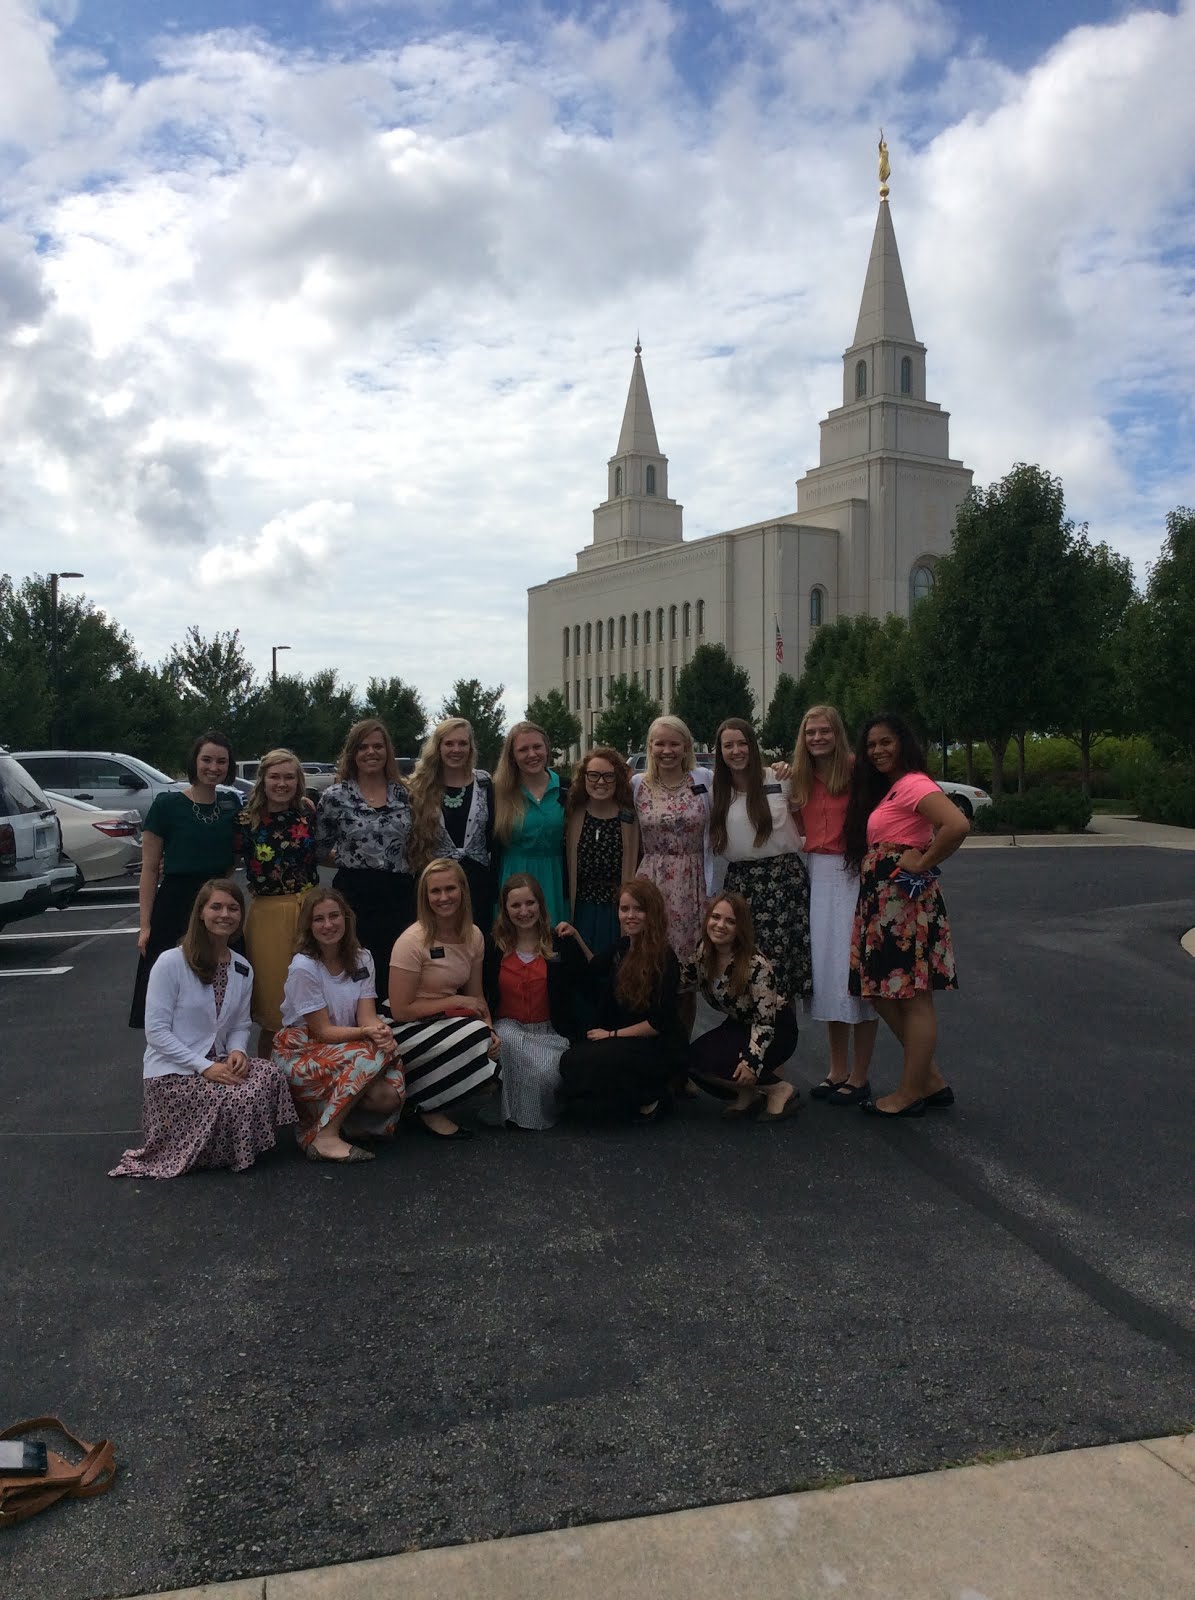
[1126, 506, 1195, 758]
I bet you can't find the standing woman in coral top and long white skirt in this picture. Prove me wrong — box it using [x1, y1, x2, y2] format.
[792, 706, 880, 1106]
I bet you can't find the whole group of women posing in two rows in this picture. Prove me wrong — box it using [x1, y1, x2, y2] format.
[114, 706, 968, 1178]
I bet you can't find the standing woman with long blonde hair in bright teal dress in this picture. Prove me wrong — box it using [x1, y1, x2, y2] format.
[494, 722, 568, 928]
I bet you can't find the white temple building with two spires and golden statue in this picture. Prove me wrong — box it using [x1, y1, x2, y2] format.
[528, 170, 971, 746]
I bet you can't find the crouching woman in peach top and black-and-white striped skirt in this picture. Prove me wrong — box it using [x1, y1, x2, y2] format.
[390, 859, 498, 1139]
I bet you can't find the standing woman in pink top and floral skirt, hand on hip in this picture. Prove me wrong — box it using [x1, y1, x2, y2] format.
[845, 715, 971, 1117]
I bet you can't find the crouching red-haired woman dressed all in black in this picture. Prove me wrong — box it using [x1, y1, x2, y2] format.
[558, 878, 683, 1122]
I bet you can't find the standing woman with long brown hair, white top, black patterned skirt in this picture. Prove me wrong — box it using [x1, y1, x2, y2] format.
[710, 717, 813, 1000]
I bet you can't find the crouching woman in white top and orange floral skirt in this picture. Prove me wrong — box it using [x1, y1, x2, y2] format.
[274, 886, 403, 1162]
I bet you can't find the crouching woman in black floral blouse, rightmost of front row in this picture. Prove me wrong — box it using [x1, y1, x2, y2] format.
[680, 894, 798, 1122]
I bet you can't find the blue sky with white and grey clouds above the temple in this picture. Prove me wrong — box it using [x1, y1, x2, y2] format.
[0, 0, 1195, 715]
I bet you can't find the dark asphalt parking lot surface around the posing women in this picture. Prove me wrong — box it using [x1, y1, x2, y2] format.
[0, 848, 1195, 1600]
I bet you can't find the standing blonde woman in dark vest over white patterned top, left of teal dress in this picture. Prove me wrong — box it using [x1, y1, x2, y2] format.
[406, 717, 494, 928]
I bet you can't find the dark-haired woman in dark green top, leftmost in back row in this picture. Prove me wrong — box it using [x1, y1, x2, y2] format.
[128, 728, 240, 1027]
